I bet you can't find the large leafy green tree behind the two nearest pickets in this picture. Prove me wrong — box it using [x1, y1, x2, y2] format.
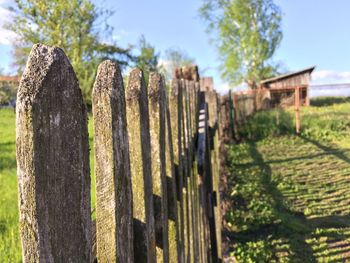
[7, 0, 133, 103]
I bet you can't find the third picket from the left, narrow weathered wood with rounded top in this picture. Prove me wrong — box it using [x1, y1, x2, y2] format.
[126, 69, 156, 262]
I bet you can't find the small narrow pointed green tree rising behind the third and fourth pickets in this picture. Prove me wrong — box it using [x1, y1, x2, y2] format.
[136, 35, 159, 83]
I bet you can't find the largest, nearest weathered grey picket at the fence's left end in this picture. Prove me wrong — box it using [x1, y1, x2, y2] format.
[16, 44, 91, 262]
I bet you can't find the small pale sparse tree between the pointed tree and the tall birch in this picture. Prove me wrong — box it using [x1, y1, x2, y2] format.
[159, 48, 195, 82]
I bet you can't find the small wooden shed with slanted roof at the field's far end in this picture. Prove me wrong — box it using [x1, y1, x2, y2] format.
[260, 66, 315, 107]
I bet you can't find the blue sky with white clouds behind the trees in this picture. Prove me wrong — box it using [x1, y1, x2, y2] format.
[0, 0, 350, 92]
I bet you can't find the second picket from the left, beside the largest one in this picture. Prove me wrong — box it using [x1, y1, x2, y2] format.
[92, 60, 134, 262]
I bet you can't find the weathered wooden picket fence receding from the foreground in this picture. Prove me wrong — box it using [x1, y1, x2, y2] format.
[16, 44, 221, 262]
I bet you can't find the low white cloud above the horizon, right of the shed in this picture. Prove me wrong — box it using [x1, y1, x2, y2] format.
[311, 70, 350, 84]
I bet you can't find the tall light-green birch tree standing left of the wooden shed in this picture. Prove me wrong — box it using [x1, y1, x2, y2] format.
[199, 0, 282, 88]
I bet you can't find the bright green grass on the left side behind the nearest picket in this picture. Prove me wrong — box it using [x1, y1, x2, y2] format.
[0, 109, 95, 263]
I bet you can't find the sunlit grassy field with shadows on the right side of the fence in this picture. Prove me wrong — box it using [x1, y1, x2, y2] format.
[225, 100, 350, 262]
